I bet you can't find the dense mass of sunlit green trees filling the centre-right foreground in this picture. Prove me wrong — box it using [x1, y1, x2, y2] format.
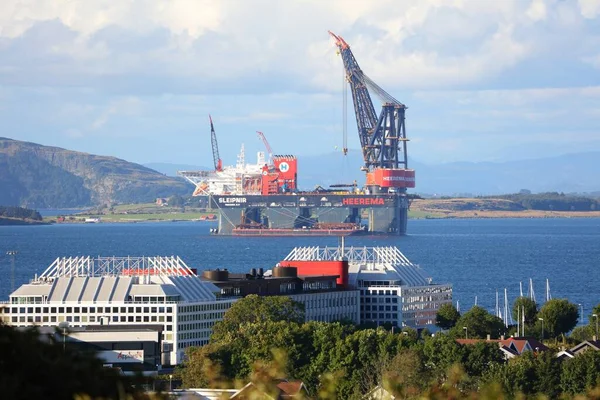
[178, 296, 600, 399]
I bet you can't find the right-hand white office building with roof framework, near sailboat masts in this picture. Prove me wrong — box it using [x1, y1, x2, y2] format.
[281, 246, 452, 329]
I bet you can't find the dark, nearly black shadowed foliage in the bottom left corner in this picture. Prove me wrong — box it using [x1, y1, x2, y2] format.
[0, 324, 155, 400]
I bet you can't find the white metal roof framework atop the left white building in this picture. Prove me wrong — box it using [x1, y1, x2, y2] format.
[38, 256, 196, 281]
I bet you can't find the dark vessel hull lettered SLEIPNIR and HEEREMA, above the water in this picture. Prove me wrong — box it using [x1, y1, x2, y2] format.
[209, 193, 409, 236]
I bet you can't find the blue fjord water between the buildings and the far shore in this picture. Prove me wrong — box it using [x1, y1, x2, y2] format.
[0, 218, 600, 321]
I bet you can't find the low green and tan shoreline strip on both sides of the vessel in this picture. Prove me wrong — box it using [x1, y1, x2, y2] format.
[0, 191, 600, 225]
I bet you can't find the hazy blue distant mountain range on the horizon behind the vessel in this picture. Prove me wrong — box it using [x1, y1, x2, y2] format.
[146, 150, 600, 195]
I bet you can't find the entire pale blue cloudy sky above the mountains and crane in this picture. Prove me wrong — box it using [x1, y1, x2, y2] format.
[0, 0, 600, 166]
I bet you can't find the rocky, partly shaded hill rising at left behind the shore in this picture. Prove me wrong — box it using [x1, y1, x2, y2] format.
[0, 137, 191, 208]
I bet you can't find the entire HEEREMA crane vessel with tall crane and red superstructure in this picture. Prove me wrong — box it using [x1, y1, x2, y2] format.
[178, 32, 415, 236]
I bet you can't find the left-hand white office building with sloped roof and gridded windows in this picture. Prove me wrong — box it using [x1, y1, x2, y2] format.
[0, 256, 237, 365]
